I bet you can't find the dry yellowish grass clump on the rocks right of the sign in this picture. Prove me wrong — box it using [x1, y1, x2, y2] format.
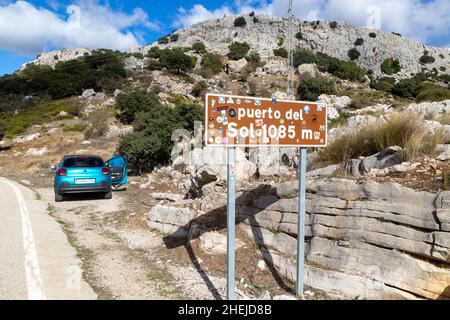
[319, 113, 441, 163]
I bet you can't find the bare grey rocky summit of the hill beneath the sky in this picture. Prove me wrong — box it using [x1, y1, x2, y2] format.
[141, 15, 450, 78]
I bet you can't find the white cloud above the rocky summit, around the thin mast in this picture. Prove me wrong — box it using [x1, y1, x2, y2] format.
[173, 0, 450, 46]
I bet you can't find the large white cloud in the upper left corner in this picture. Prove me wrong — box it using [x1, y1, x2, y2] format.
[0, 0, 157, 55]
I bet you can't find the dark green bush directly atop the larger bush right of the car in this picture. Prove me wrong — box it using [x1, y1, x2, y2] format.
[116, 90, 163, 124]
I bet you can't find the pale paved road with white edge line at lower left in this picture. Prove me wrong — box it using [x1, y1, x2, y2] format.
[0, 178, 97, 299]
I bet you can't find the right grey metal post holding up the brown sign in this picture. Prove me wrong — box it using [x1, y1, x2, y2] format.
[296, 148, 306, 297]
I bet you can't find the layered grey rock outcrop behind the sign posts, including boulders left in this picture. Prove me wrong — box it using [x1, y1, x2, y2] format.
[149, 178, 450, 299]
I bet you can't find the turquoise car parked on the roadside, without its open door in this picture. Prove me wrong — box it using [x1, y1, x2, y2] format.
[52, 155, 112, 202]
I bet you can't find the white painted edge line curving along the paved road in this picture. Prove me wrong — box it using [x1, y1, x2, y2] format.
[0, 177, 46, 300]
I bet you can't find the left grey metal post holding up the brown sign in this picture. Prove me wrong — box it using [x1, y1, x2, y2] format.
[227, 147, 236, 300]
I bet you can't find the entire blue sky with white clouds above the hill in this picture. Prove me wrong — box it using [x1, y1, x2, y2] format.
[0, 0, 450, 75]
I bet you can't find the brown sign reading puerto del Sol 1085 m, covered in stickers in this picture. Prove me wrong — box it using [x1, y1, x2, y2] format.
[205, 94, 327, 147]
